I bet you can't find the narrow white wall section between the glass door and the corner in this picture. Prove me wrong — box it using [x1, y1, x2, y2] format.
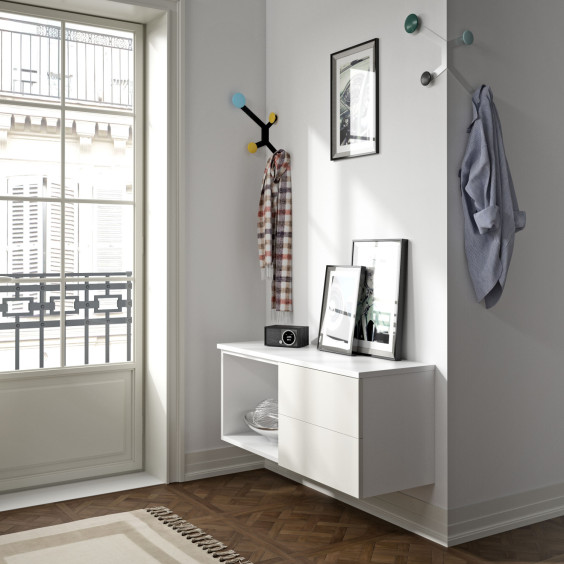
[184, 0, 266, 452]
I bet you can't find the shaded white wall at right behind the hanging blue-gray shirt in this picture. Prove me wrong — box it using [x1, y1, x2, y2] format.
[448, 0, 564, 508]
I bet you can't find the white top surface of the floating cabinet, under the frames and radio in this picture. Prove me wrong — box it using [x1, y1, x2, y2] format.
[217, 341, 435, 378]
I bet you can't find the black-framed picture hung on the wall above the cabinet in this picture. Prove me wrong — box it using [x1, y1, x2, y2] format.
[331, 39, 379, 160]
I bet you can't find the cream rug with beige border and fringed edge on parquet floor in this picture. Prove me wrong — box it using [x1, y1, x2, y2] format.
[0, 507, 252, 564]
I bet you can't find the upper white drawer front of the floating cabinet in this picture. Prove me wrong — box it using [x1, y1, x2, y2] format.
[278, 364, 361, 438]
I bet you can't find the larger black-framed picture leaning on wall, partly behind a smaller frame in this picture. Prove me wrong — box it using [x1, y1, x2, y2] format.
[352, 239, 407, 360]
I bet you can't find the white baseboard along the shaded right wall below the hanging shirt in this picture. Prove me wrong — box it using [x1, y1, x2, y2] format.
[448, 484, 564, 546]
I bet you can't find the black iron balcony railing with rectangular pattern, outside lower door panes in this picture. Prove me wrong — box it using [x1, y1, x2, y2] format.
[0, 272, 133, 370]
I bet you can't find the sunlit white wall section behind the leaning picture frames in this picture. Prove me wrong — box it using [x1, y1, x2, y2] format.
[266, 0, 447, 507]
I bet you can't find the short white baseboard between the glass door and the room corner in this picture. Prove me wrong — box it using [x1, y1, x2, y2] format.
[184, 446, 264, 482]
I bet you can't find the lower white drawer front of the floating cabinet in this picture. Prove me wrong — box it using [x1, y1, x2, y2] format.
[278, 414, 361, 497]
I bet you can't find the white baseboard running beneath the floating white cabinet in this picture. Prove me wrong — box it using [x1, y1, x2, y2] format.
[264, 460, 447, 546]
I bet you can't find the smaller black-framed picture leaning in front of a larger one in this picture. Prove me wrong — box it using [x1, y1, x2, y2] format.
[317, 266, 364, 355]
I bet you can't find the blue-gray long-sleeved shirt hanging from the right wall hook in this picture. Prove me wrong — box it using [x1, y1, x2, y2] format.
[459, 85, 525, 308]
